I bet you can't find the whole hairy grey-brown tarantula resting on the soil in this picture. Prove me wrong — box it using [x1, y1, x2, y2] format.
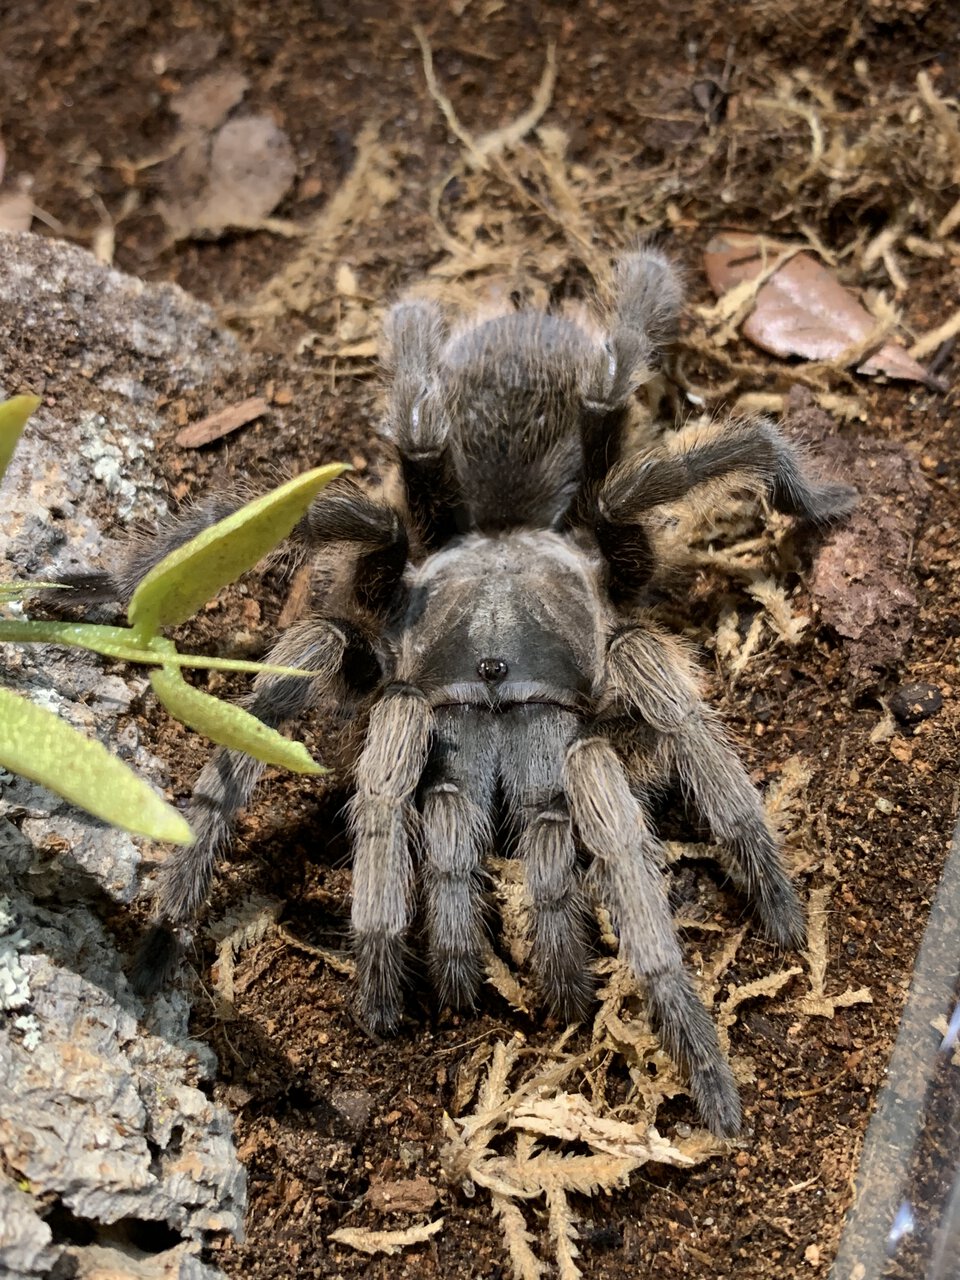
[75, 248, 854, 1134]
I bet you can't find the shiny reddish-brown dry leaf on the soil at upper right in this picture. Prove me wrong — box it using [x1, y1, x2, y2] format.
[704, 232, 931, 383]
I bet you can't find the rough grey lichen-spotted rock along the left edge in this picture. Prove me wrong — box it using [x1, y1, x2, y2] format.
[0, 234, 246, 1280]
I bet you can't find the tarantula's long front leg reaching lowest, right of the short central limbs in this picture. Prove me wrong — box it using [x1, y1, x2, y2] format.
[564, 739, 741, 1135]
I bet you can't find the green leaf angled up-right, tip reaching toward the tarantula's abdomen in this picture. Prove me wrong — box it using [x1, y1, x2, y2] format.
[127, 462, 349, 639]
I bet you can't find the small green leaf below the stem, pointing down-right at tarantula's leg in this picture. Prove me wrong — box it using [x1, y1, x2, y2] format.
[150, 667, 326, 773]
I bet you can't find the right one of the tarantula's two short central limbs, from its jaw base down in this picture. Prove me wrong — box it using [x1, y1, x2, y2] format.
[499, 707, 594, 1021]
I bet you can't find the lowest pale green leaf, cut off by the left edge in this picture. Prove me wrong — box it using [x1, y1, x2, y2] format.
[0, 687, 193, 845]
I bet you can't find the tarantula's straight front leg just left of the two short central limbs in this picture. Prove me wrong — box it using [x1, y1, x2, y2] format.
[349, 685, 433, 1034]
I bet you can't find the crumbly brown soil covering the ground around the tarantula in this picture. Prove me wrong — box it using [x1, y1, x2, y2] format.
[0, 0, 960, 1280]
